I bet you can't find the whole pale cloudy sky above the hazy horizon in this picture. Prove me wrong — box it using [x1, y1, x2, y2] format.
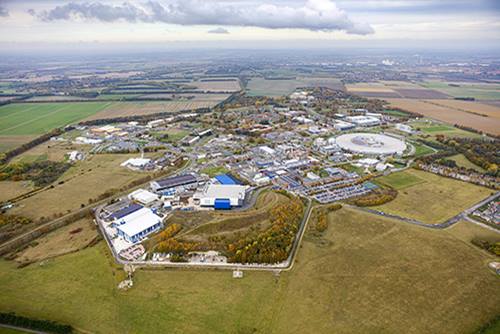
[0, 0, 500, 49]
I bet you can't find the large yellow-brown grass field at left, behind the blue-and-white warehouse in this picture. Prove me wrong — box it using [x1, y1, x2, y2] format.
[10, 154, 156, 219]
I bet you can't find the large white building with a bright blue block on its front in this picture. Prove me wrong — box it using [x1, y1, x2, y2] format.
[193, 184, 248, 209]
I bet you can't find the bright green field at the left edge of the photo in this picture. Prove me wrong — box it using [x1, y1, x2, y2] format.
[0, 102, 111, 136]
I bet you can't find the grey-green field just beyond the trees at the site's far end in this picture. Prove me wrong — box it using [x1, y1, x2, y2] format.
[247, 77, 344, 96]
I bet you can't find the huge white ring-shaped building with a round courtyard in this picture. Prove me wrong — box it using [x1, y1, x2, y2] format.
[335, 133, 406, 155]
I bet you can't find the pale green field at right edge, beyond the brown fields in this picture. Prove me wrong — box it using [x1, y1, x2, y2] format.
[422, 81, 500, 100]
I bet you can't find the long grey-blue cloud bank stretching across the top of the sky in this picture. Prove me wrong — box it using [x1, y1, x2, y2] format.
[32, 0, 373, 35]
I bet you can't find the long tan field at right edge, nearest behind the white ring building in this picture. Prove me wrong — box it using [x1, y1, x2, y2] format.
[387, 99, 500, 135]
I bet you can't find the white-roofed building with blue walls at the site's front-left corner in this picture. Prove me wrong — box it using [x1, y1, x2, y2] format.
[113, 207, 163, 243]
